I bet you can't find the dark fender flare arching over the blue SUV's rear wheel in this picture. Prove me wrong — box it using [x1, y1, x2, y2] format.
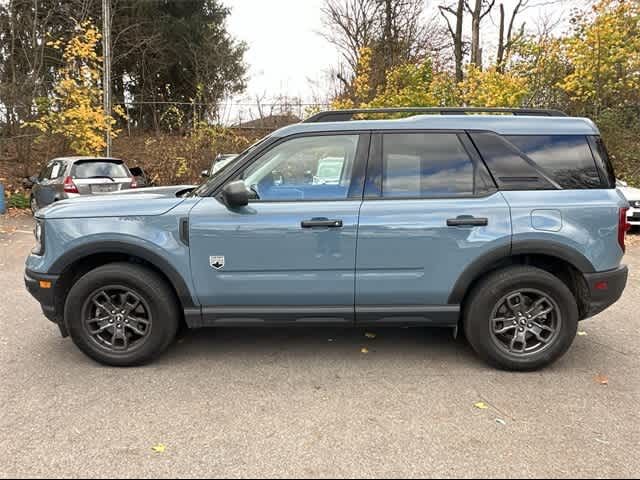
[448, 240, 596, 305]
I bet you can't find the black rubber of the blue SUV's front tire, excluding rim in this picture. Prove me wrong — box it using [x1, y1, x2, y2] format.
[64, 265, 178, 366]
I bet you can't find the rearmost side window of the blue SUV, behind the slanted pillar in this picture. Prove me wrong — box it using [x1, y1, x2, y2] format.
[506, 135, 603, 189]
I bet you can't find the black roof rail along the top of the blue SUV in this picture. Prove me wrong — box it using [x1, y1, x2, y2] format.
[303, 107, 567, 123]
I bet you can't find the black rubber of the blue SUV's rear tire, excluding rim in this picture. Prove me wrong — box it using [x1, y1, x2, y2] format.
[465, 267, 578, 371]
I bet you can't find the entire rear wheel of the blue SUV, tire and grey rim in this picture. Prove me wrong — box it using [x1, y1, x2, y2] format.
[464, 266, 578, 371]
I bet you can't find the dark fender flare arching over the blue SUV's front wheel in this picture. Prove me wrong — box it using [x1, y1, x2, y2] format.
[48, 240, 196, 309]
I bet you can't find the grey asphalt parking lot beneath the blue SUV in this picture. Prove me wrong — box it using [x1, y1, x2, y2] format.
[0, 212, 640, 478]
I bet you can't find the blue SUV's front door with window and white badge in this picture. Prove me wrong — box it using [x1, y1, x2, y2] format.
[189, 134, 369, 325]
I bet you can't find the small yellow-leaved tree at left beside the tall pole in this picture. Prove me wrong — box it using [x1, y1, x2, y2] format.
[30, 21, 122, 155]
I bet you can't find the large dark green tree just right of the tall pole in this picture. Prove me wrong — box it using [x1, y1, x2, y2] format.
[112, 0, 247, 130]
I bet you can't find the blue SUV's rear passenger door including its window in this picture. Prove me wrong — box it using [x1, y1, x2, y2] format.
[356, 132, 511, 325]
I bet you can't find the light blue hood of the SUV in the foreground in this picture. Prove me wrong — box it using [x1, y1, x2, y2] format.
[36, 185, 193, 219]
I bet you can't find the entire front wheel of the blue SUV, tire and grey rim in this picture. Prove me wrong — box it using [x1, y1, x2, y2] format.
[64, 263, 180, 367]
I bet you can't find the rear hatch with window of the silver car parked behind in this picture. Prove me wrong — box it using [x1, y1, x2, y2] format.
[71, 159, 132, 195]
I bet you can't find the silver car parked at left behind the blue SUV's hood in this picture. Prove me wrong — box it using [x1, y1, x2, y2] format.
[29, 157, 138, 212]
